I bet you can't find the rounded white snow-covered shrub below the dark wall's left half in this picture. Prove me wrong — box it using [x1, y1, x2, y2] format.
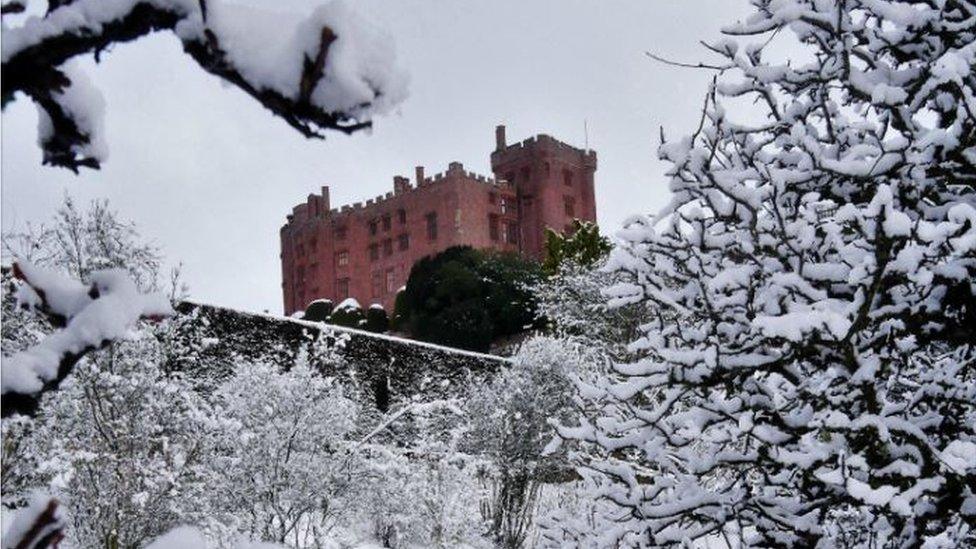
[210, 356, 363, 547]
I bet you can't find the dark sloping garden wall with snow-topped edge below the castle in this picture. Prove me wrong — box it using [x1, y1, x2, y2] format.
[169, 302, 509, 411]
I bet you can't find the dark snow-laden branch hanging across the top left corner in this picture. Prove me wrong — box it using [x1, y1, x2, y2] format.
[2, 0, 406, 172]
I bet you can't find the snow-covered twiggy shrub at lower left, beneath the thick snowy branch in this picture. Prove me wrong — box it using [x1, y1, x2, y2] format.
[4, 334, 213, 547]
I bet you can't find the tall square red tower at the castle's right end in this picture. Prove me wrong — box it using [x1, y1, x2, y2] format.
[491, 126, 596, 259]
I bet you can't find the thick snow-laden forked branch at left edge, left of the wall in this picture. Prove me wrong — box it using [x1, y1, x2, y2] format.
[0, 262, 173, 417]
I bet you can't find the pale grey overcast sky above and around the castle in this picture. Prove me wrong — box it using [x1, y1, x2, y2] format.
[2, 0, 747, 312]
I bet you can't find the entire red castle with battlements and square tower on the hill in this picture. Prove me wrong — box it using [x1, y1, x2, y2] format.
[281, 126, 596, 314]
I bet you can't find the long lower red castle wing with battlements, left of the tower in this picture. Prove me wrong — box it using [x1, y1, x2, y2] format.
[281, 163, 518, 314]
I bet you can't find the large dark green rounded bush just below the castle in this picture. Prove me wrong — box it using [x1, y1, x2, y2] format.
[396, 246, 540, 351]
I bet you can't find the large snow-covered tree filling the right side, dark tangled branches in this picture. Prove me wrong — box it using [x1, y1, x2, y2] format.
[561, 0, 976, 547]
